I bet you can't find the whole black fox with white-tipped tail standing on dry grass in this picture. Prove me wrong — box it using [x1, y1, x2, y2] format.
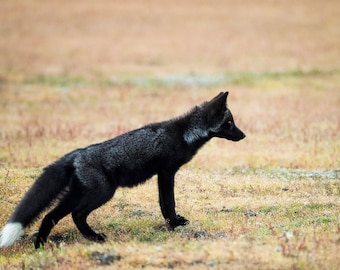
[0, 92, 245, 248]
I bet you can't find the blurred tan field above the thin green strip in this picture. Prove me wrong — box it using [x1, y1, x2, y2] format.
[0, 0, 340, 76]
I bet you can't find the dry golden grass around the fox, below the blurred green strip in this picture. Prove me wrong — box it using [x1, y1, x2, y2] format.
[0, 81, 340, 269]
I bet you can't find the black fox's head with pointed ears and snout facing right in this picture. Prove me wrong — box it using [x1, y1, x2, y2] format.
[205, 92, 246, 142]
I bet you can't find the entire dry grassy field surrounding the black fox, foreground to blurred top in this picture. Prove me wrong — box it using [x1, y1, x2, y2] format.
[0, 0, 340, 269]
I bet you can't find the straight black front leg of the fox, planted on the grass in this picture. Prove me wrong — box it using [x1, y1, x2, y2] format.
[158, 172, 189, 229]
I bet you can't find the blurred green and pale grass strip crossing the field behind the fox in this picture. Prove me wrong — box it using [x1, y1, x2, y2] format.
[11, 68, 340, 89]
